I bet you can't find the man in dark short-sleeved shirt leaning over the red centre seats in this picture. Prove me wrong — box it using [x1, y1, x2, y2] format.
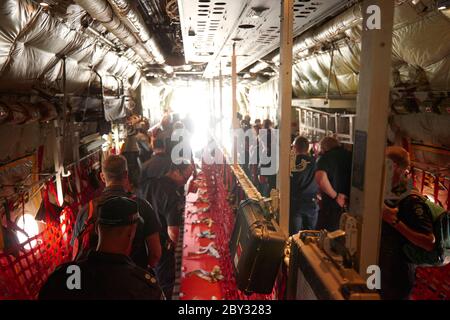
[143, 160, 193, 299]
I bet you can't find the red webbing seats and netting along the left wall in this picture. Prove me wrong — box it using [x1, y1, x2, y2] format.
[0, 155, 101, 300]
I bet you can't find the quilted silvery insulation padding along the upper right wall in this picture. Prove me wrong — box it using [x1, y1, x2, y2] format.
[251, 0, 450, 99]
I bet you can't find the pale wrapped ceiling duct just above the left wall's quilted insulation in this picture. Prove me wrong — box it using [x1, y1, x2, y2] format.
[75, 0, 164, 64]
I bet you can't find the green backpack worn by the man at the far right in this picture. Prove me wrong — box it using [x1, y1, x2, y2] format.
[403, 195, 450, 266]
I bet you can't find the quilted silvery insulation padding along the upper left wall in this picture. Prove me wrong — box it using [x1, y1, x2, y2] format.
[0, 0, 142, 93]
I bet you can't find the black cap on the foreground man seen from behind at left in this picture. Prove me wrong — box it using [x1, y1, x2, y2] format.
[97, 197, 144, 226]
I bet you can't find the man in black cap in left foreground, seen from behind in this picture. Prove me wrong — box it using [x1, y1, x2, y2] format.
[39, 197, 164, 300]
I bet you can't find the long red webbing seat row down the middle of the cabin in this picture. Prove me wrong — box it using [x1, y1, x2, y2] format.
[180, 168, 273, 300]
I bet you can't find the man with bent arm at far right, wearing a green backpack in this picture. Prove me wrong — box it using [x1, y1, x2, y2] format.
[379, 147, 436, 300]
